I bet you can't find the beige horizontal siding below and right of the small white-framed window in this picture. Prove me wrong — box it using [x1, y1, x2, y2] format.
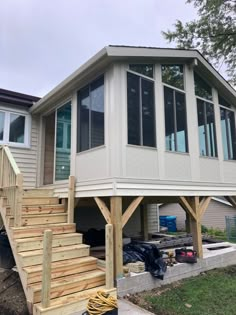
[10, 117, 39, 188]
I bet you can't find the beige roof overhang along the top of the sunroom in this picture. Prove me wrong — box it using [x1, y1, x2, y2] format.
[31, 46, 236, 114]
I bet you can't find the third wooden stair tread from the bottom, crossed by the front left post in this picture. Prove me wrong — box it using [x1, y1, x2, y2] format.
[23, 256, 97, 274]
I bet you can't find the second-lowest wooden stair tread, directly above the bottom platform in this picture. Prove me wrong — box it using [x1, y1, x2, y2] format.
[30, 269, 106, 292]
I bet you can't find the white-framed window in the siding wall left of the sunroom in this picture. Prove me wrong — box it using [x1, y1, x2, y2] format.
[0, 110, 29, 146]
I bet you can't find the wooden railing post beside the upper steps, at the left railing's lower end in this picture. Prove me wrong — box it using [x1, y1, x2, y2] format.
[14, 173, 23, 227]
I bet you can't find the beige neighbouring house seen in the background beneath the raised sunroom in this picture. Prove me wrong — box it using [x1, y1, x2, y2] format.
[159, 197, 236, 231]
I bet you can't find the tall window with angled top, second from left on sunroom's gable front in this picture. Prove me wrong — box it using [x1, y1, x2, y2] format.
[162, 65, 188, 152]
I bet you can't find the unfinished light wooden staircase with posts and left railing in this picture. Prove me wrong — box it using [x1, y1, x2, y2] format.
[0, 146, 116, 315]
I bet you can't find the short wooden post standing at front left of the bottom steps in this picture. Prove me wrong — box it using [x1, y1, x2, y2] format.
[41, 230, 52, 308]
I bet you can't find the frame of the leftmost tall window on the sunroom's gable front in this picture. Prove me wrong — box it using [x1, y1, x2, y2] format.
[126, 68, 157, 149]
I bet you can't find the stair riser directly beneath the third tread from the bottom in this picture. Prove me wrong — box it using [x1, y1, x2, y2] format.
[27, 262, 97, 285]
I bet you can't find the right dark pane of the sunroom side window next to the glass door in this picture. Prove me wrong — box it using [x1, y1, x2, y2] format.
[90, 77, 104, 148]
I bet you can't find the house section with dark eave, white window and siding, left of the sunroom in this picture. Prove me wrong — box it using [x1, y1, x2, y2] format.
[0, 89, 40, 188]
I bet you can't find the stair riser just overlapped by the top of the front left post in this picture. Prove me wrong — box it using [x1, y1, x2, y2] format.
[12, 224, 75, 239]
